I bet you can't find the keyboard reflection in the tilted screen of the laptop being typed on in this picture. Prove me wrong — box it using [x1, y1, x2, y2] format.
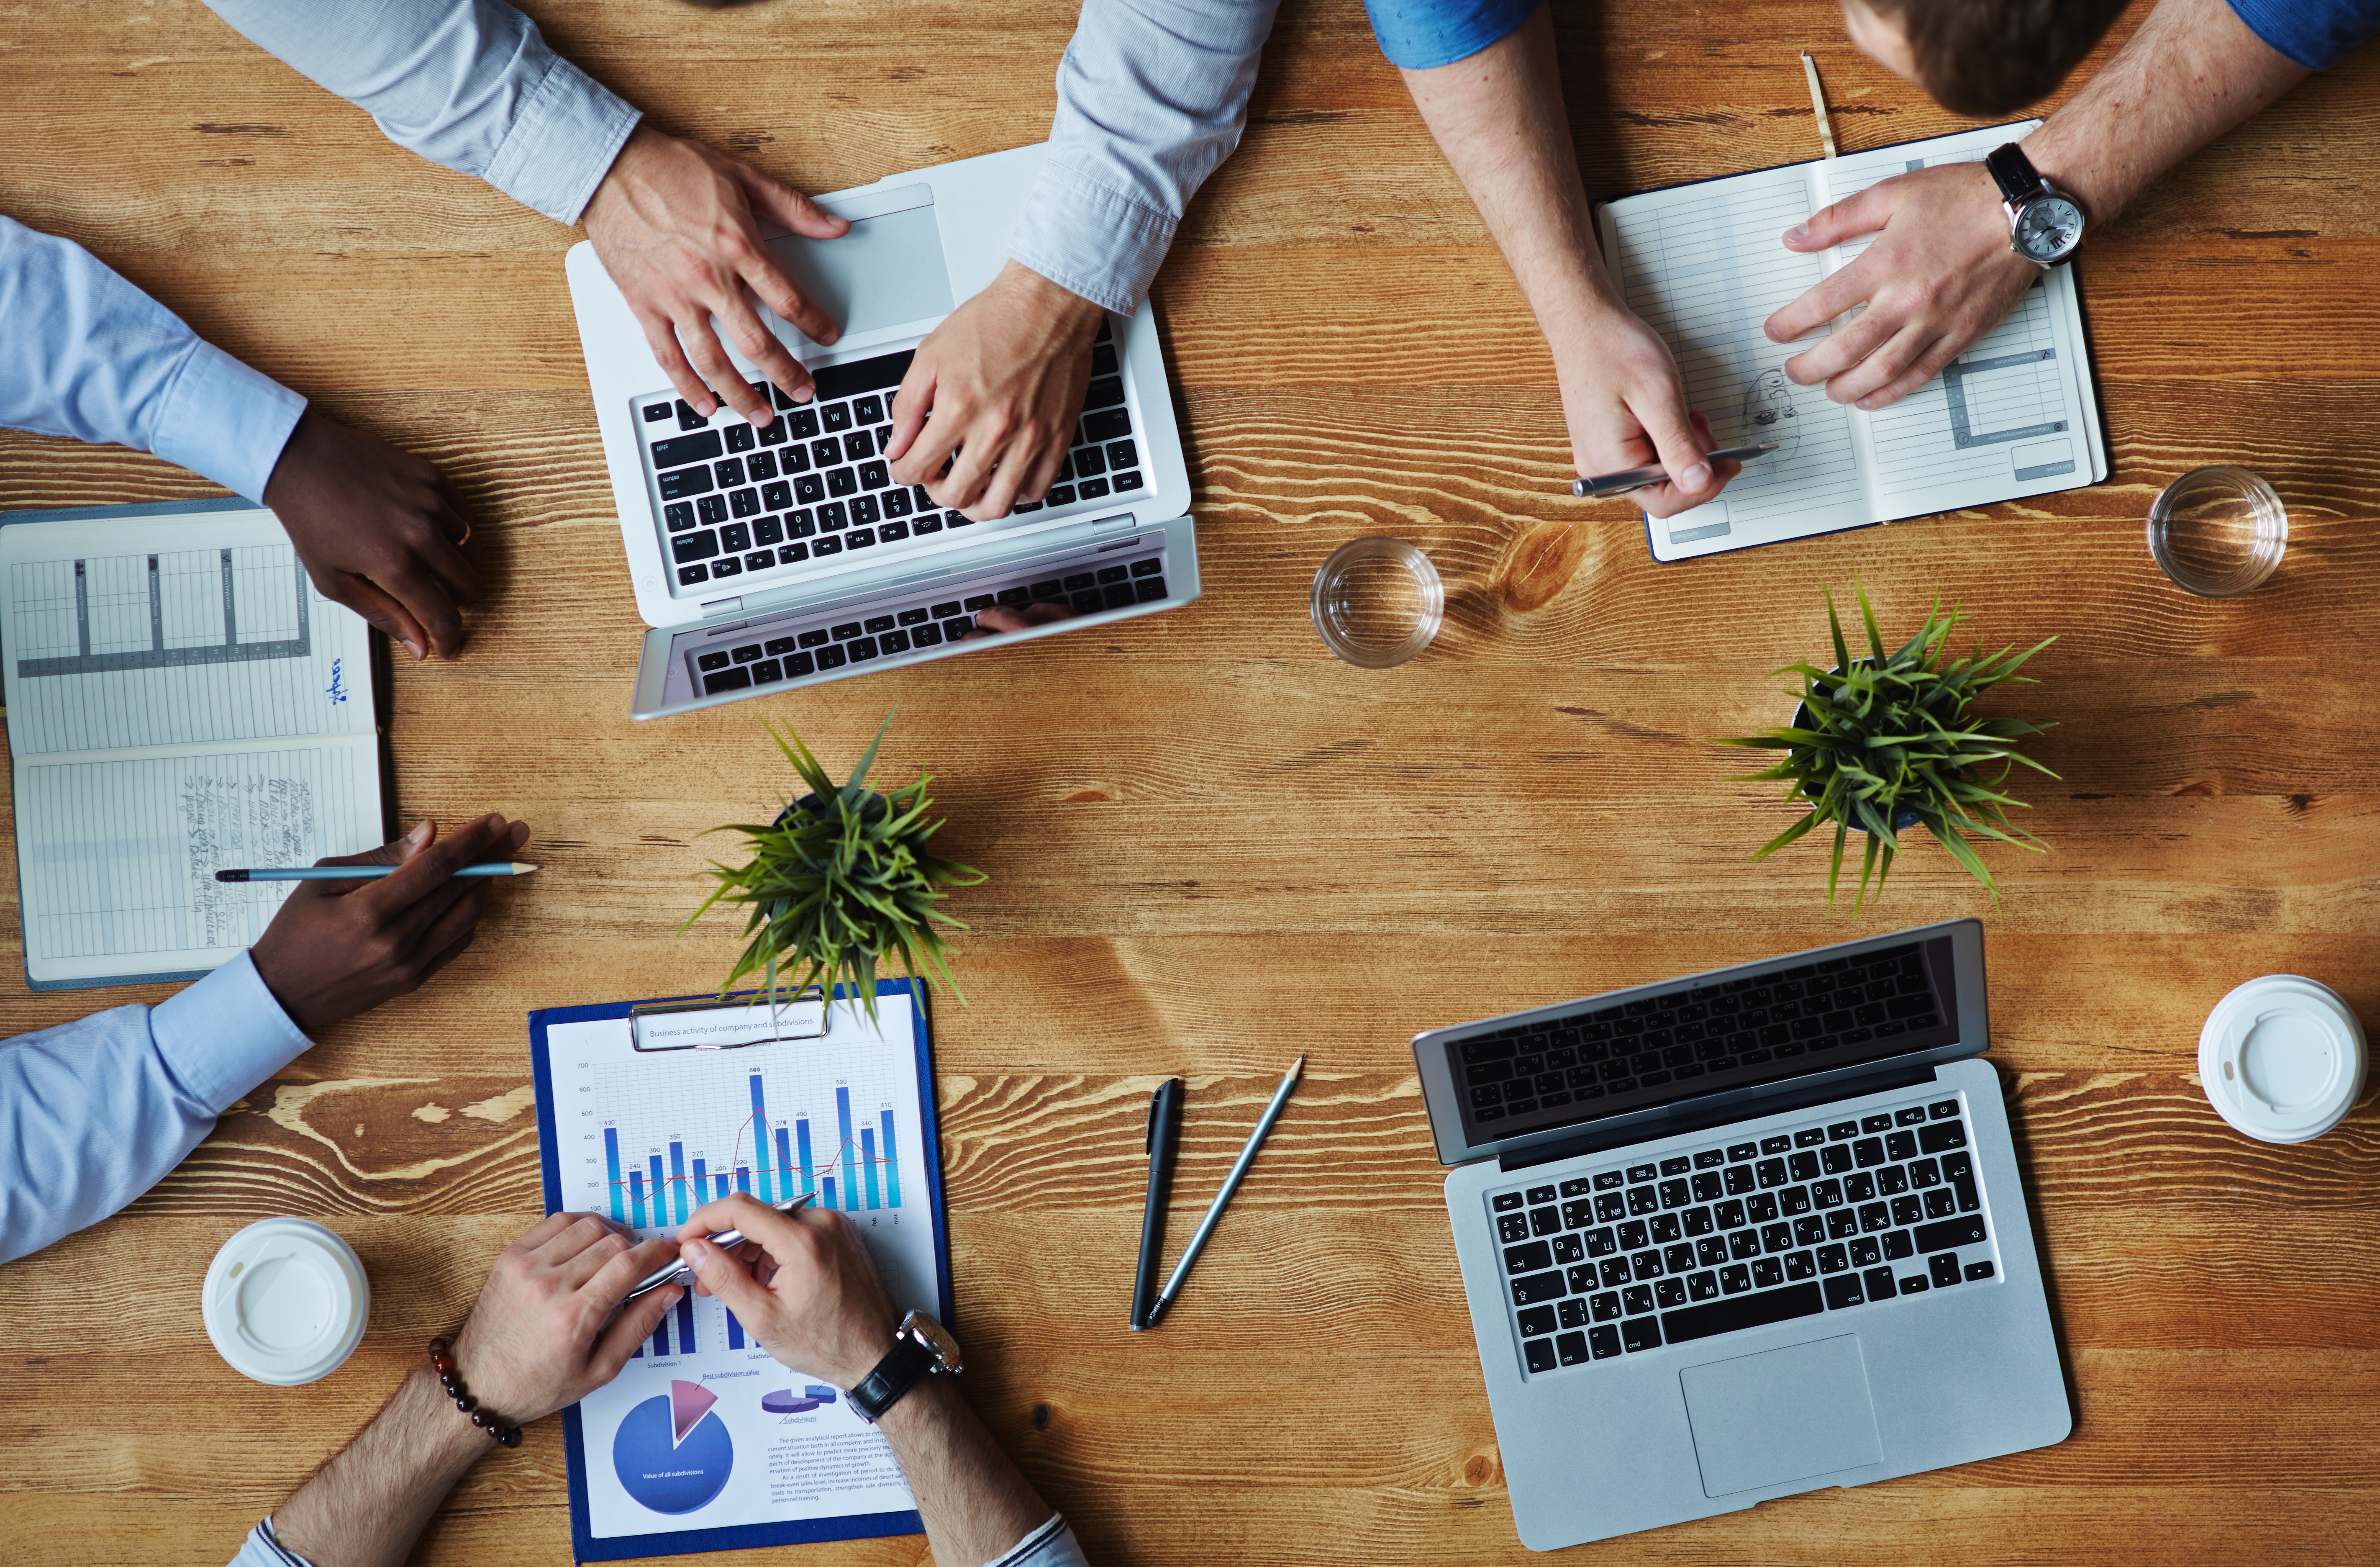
[685, 548, 1166, 695]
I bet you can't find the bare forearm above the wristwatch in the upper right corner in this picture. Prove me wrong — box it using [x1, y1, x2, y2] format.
[2025, 0, 2306, 229]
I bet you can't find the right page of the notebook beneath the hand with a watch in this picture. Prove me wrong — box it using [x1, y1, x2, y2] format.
[1818, 121, 2106, 517]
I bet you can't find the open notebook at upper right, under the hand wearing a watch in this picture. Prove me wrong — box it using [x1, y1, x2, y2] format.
[1597, 119, 2106, 560]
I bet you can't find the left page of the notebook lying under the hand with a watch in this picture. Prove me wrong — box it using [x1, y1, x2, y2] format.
[1602, 167, 1875, 557]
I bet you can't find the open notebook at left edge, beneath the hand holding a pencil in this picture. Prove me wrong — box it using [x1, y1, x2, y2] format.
[0, 500, 393, 991]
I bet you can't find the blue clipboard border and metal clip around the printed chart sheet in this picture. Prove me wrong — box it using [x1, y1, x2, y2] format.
[528, 979, 954, 1562]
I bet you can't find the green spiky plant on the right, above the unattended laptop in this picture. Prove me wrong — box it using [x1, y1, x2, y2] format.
[1718, 583, 2056, 912]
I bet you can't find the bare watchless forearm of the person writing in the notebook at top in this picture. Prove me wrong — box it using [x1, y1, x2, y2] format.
[1404, 7, 1626, 367]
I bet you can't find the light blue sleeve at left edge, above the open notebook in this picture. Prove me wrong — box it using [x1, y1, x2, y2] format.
[0, 217, 305, 503]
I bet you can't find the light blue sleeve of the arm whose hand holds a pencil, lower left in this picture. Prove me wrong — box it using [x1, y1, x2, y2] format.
[0, 953, 307, 1262]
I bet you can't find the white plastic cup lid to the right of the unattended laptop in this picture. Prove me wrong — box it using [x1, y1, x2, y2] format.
[2199, 974, 2363, 1143]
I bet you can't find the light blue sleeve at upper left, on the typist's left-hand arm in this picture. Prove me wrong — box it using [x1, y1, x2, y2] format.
[207, 0, 638, 224]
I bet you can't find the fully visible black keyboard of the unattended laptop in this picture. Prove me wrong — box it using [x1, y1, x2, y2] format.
[1488, 1098, 1995, 1374]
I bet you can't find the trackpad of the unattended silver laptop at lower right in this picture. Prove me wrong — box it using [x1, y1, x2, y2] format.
[1678, 1333, 1885, 1495]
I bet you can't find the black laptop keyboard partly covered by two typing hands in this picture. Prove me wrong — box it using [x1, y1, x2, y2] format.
[636, 321, 1147, 591]
